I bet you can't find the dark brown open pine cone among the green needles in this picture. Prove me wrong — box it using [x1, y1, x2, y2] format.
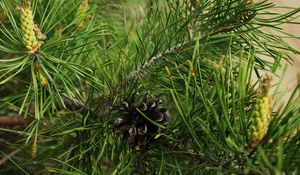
[111, 92, 170, 148]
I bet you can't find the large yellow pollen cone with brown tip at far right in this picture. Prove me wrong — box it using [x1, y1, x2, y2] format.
[249, 77, 271, 148]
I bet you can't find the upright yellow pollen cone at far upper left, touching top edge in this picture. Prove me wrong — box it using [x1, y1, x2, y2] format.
[19, 0, 40, 53]
